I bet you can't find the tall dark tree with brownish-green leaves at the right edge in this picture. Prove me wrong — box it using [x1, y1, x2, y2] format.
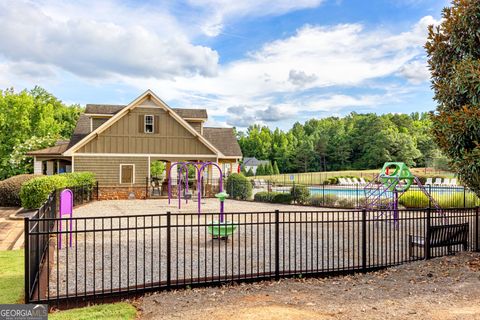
[425, 0, 480, 196]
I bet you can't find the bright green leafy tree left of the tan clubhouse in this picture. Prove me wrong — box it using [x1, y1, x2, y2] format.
[0, 87, 82, 179]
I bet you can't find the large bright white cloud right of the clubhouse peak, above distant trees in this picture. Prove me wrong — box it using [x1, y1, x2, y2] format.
[127, 16, 435, 126]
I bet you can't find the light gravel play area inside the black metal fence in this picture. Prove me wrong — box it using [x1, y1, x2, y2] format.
[47, 199, 476, 297]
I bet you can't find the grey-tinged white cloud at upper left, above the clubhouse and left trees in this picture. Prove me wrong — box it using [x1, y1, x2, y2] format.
[0, 1, 218, 79]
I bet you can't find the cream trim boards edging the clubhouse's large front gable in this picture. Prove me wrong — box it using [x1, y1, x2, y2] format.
[64, 90, 223, 156]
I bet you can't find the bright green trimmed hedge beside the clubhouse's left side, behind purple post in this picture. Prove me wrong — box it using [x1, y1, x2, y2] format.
[20, 172, 96, 209]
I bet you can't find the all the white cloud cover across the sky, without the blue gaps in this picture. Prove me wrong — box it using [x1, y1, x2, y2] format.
[0, 0, 436, 127]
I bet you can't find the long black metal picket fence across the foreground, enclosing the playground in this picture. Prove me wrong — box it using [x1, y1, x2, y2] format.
[25, 208, 479, 304]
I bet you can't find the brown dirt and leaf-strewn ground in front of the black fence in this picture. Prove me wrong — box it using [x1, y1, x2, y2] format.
[137, 253, 480, 320]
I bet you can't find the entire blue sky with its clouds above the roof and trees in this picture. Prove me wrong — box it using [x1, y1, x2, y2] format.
[0, 0, 448, 129]
